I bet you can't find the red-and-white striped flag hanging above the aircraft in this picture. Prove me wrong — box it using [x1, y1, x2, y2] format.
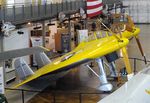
[87, 0, 103, 17]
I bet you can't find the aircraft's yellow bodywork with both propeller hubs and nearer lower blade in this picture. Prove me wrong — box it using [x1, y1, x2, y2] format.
[14, 15, 140, 88]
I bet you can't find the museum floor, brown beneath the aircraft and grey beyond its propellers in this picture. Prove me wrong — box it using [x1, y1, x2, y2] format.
[5, 25, 150, 103]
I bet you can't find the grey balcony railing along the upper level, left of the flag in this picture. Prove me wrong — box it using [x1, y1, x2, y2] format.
[0, 0, 85, 24]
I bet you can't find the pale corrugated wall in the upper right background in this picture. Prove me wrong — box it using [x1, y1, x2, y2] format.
[123, 0, 150, 23]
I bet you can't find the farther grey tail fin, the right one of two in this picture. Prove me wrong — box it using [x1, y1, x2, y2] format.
[35, 52, 51, 68]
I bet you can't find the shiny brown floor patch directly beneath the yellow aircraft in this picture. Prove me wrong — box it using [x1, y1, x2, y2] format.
[27, 67, 125, 103]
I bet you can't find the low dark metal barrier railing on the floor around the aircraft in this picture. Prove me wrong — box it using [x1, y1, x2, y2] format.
[5, 57, 150, 103]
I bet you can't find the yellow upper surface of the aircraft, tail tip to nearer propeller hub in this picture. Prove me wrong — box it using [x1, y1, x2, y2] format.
[14, 36, 129, 88]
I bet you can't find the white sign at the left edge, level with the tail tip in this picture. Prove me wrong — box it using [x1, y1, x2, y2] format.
[0, 67, 5, 94]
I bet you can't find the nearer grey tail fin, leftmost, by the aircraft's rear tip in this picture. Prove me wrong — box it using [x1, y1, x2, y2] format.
[14, 58, 34, 80]
